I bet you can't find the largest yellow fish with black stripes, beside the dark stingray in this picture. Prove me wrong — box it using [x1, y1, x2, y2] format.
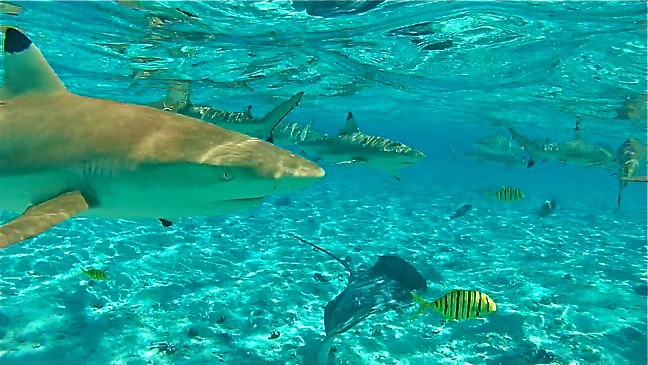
[412, 290, 497, 320]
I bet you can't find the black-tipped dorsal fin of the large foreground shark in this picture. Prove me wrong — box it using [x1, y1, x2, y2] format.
[0, 27, 66, 99]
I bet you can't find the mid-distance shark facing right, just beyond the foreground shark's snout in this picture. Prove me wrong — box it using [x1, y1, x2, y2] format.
[297, 112, 425, 179]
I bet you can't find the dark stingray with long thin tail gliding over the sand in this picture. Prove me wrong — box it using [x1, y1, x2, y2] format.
[291, 235, 427, 365]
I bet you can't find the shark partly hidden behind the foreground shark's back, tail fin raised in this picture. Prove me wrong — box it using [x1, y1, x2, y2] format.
[150, 81, 304, 142]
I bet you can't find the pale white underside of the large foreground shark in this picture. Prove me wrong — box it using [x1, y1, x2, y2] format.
[0, 165, 274, 219]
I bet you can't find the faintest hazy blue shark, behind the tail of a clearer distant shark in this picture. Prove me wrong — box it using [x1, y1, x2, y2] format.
[450, 135, 526, 167]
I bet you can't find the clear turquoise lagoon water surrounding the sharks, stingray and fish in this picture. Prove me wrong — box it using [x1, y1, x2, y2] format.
[0, 1, 648, 364]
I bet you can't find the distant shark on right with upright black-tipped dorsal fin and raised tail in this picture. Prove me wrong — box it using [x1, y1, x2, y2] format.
[509, 118, 615, 168]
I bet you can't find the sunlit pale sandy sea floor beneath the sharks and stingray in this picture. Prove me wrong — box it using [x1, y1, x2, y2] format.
[0, 169, 647, 365]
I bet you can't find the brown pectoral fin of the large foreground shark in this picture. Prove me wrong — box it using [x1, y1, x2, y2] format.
[0, 191, 88, 248]
